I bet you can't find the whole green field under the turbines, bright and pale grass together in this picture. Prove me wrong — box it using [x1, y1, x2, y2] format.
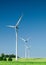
[0, 58, 46, 65]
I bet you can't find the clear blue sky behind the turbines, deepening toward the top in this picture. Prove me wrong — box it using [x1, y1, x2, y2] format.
[0, 0, 46, 57]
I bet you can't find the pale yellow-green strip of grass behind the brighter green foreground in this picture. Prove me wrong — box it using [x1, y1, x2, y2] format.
[18, 58, 46, 62]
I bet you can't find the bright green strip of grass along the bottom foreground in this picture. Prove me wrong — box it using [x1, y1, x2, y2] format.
[0, 61, 46, 65]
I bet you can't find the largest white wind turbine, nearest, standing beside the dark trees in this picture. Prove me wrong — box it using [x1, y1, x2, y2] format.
[7, 15, 23, 61]
